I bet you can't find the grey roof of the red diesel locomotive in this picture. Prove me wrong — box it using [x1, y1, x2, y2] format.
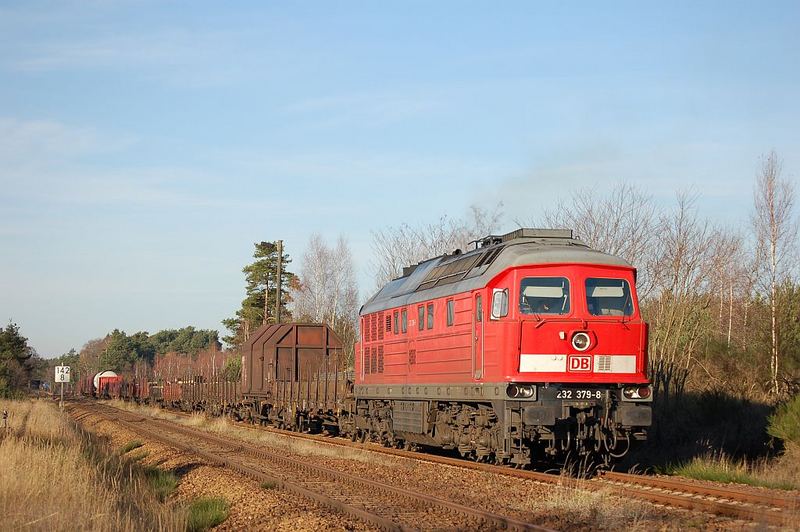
[361, 229, 633, 315]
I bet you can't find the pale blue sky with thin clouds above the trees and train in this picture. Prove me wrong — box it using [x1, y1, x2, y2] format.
[0, 0, 800, 356]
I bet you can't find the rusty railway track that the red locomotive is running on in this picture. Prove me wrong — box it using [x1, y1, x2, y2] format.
[152, 402, 800, 526]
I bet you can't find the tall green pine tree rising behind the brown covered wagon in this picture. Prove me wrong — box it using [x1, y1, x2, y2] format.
[222, 242, 296, 347]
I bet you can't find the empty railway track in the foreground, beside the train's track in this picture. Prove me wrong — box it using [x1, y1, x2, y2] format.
[76, 404, 548, 530]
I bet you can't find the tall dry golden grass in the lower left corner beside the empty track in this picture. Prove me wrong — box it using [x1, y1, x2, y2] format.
[0, 401, 186, 531]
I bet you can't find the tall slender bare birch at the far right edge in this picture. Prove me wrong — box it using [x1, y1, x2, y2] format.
[752, 151, 797, 394]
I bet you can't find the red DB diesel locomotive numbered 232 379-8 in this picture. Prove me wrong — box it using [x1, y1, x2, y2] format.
[354, 229, 652, 465]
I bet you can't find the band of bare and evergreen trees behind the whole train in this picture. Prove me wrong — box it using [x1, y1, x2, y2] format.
[0, 153, 800, 401]
